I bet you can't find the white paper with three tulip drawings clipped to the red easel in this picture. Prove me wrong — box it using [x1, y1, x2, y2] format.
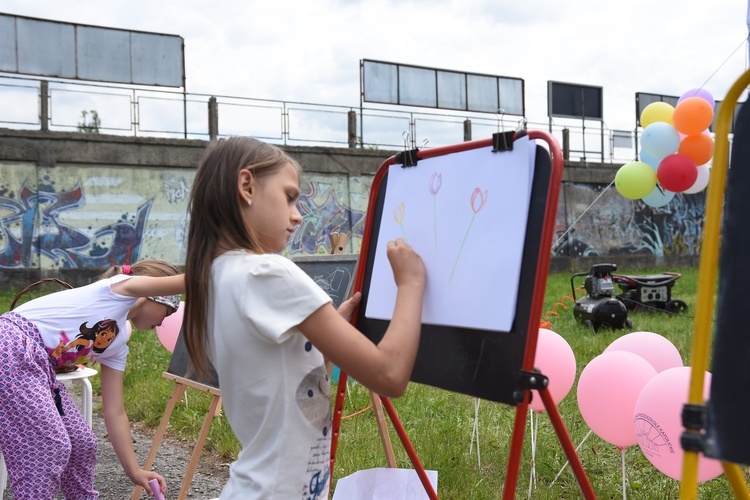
[365, 137, 536, 331]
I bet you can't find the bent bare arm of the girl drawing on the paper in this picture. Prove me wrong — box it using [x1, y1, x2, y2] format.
[299, 238, 426, 397]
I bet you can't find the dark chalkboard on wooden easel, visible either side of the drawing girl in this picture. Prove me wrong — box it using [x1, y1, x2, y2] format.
[167, 254, 358, 388]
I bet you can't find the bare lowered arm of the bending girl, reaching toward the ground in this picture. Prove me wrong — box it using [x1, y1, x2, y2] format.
[100, 365, 167, 495]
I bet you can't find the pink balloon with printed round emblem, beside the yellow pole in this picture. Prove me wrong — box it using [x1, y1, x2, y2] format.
[633, 366, 723, 482]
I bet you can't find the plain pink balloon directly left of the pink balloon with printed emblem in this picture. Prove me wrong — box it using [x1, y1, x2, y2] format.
[578, 351, 656, 449]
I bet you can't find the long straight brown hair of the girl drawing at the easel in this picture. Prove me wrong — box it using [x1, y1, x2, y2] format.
[183, 137, 301, 377]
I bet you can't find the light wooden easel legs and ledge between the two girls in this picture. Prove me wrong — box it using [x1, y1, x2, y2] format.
[130, 372, 221, 500]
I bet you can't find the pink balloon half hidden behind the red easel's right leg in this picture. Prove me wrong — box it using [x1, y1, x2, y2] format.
[529, 328, 576, 412]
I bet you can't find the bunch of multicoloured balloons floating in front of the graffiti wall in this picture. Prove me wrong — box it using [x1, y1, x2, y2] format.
[615, 89, 714, 207]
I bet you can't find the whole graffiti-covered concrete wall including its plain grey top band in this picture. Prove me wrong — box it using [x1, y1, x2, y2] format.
[0, 129, 705, 290]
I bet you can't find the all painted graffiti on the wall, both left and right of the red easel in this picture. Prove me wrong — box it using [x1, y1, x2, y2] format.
[0, 163, 705, 269]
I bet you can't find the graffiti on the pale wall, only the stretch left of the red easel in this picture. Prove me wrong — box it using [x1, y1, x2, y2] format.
[0, 164, 371, 269]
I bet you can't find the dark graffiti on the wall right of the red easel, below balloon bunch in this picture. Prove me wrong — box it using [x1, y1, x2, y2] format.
[553, 183, 705, 257]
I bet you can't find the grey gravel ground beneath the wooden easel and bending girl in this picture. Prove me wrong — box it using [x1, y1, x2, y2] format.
[0, 396, 229, 500]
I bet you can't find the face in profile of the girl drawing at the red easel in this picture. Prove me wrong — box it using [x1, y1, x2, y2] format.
[248, 163, 302, 252]
